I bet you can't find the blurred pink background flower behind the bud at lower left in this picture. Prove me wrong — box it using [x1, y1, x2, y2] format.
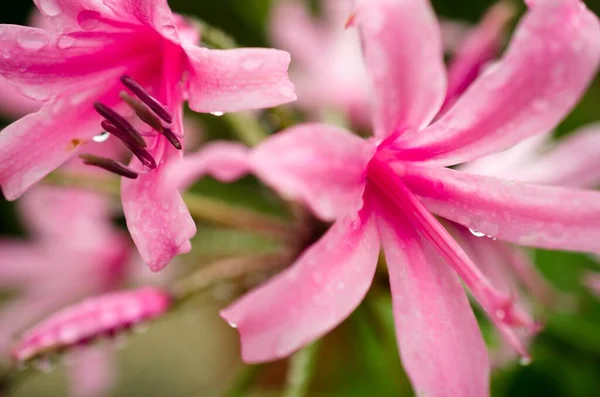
[0, 187, 130, 396]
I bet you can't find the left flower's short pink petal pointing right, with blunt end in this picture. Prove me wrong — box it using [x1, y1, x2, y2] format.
[184, 46, 296, 113]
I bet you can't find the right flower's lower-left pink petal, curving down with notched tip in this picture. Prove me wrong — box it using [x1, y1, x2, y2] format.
[221, 213, 379, 363]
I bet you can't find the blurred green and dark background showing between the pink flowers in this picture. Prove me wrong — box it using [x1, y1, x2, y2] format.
[0, 0, 600, 397]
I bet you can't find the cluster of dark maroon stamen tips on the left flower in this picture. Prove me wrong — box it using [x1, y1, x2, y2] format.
[79, 76, 182, 179]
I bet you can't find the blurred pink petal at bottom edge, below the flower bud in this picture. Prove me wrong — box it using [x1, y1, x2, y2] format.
[69, 347, 117, 397]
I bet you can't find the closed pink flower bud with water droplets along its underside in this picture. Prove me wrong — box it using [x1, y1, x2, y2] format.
[12, 287, 170, 362]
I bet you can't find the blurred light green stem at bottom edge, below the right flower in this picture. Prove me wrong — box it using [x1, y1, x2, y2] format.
[283, 341, 320, 397]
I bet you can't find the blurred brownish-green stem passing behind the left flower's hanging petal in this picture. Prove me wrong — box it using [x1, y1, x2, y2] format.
[44, 173, 293, 240]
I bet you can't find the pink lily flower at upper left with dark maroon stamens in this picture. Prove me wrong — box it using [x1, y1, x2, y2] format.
[0, 0, 295, 271]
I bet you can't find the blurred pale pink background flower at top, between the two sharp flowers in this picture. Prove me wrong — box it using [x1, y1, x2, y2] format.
[270, 0, 370, 126]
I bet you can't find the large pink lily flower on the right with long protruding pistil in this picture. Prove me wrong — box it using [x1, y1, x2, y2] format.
[169, 0, 600, 396]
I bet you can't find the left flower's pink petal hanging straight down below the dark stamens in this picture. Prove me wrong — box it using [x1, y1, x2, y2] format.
[121, 145, 196, 272]
